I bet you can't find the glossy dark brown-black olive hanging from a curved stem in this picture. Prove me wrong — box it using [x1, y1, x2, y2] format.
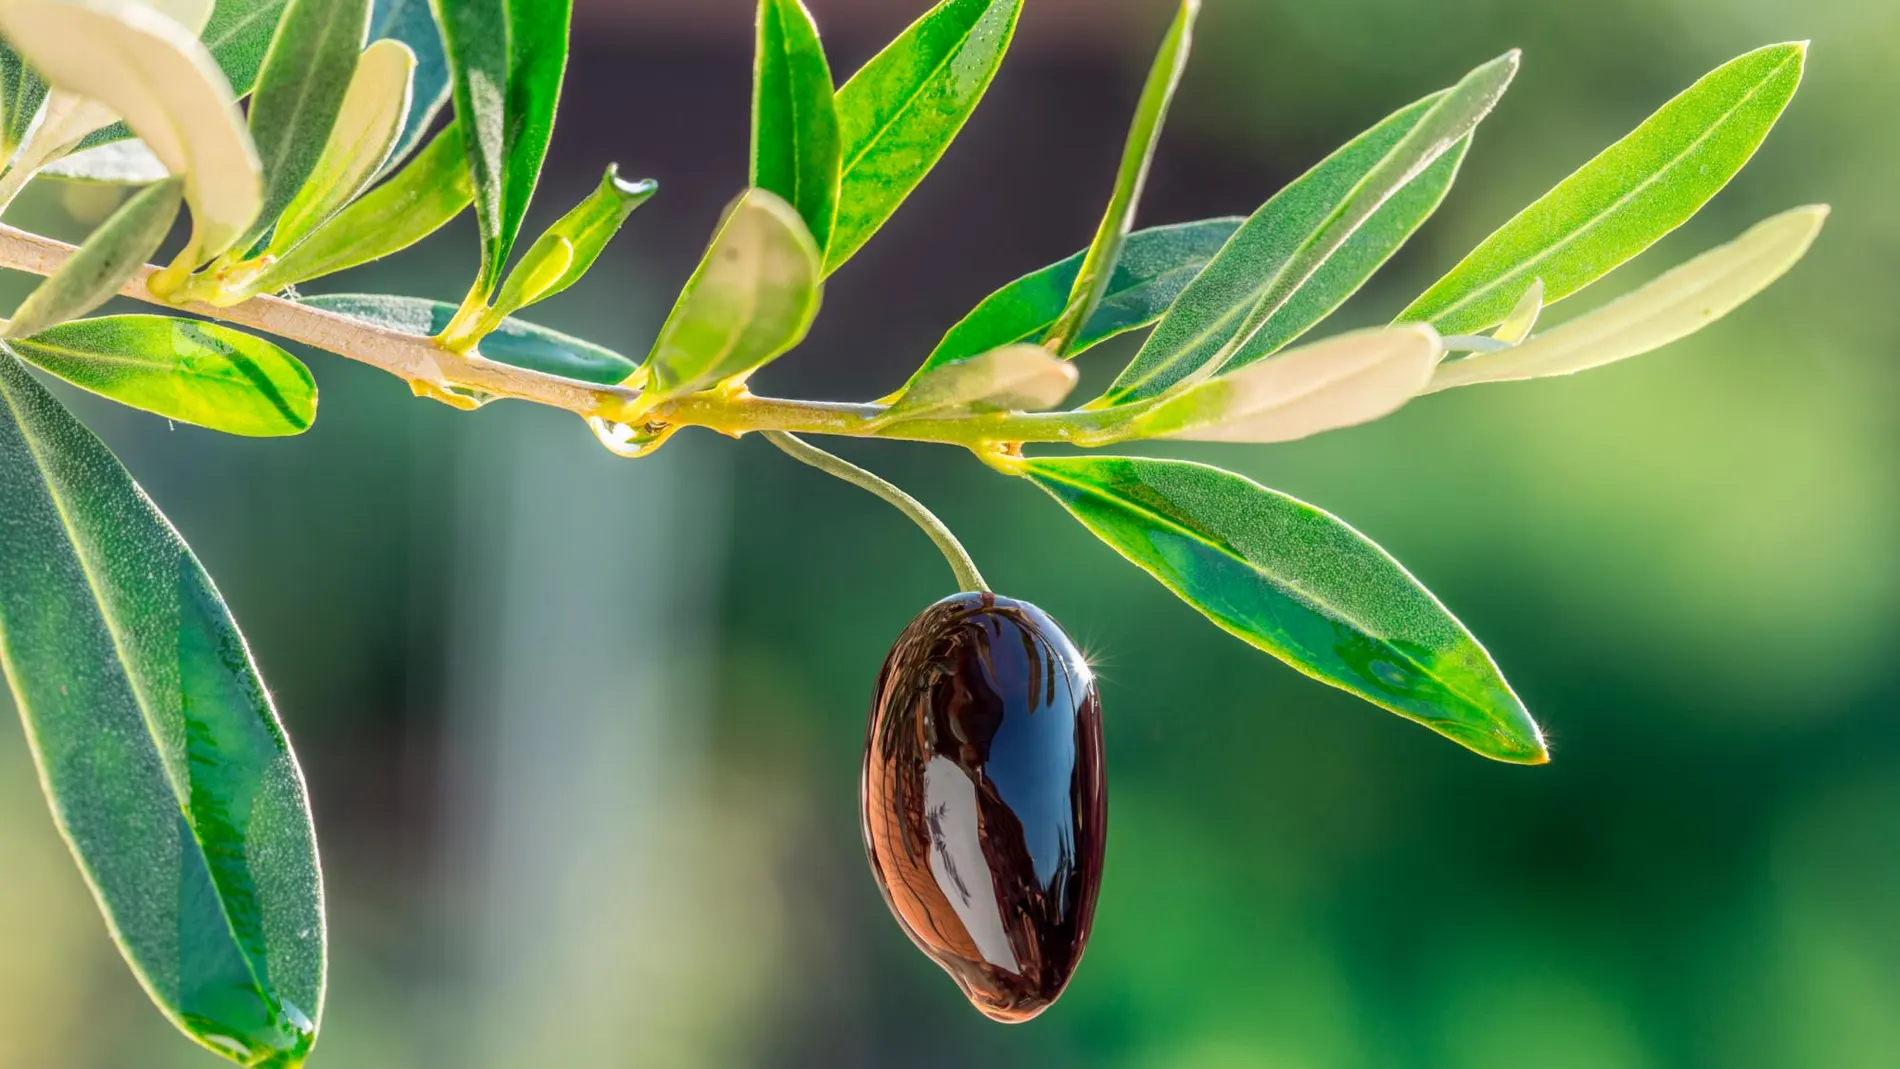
[861, 594, 1108, 1022]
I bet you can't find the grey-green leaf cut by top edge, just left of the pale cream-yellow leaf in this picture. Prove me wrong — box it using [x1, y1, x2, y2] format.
[238, 0, 368, 254]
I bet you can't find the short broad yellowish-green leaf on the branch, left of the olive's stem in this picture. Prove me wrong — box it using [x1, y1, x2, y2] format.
[646, 190, 825, 401]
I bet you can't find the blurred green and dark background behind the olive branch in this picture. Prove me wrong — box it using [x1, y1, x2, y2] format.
[0, 0, 1900, 1069]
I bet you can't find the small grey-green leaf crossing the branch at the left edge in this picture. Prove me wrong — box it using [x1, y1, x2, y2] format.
[0, 178, 184, 338]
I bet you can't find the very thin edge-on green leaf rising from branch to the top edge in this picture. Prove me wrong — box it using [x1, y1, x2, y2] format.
[1043, 0, 1201, 355]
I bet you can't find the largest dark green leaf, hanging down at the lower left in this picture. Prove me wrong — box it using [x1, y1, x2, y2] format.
[0, 346, 325, 1069]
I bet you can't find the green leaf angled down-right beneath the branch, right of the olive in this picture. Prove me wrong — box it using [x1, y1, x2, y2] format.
[1022, 456, 1549, 765]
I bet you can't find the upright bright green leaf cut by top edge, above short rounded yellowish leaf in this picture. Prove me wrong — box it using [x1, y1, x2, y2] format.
[752, 0, 844, 249]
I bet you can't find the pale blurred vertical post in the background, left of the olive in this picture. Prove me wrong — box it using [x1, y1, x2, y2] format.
[443, 396, 726, 1069]
